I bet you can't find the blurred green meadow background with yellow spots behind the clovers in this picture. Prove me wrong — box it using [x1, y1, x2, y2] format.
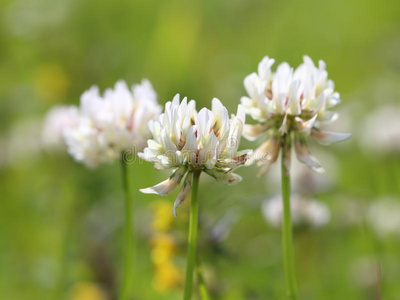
[0, 0, 400, 300]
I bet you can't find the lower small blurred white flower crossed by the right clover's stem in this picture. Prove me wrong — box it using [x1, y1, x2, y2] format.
[262, 194, 331, 228]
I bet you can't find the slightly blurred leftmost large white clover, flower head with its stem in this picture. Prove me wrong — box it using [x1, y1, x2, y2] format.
[60, 79, 161, 300]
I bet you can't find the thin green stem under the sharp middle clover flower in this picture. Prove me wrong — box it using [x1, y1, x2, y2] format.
[183, 171, 201, 300]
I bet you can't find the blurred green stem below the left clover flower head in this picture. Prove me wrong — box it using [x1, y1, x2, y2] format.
[119, 156, 134, 300]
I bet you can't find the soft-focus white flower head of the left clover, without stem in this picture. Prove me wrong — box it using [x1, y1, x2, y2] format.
[65, 79, 161, 167]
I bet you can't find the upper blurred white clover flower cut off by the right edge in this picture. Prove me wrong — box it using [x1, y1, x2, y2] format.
[360, 104, 400, 154]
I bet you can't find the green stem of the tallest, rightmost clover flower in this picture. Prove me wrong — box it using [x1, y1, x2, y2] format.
[281, 139, 297, 300]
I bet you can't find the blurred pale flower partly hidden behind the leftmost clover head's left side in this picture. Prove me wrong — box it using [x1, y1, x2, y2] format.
[41, 105, 79, 150]
